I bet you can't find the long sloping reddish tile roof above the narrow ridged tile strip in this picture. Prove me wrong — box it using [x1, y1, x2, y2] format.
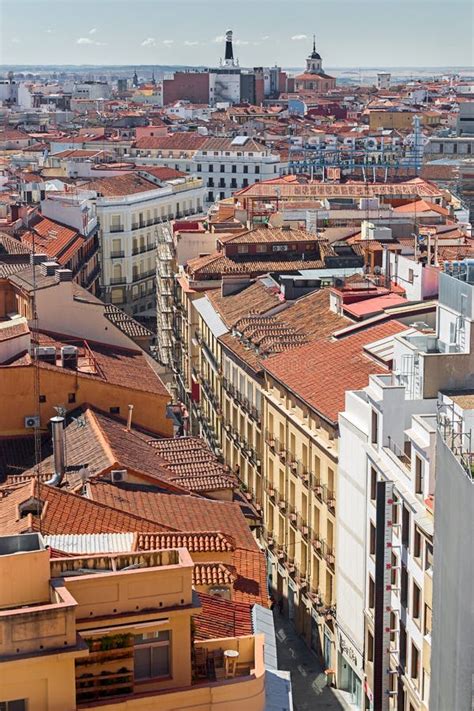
[88, 480, 257, 550]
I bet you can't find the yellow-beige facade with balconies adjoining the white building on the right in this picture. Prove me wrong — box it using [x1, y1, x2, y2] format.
[263, 373, 337, 670]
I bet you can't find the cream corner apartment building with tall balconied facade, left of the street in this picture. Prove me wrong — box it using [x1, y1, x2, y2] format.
[87, 168, 204, 320]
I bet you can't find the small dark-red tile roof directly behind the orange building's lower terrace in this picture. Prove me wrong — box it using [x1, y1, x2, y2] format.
[193, 592, 253, 639]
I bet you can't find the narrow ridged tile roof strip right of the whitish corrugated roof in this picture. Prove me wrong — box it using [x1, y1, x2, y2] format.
[134, 531, 235, 553]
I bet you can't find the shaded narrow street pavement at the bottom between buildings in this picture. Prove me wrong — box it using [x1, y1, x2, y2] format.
[275, 613, 347, 711]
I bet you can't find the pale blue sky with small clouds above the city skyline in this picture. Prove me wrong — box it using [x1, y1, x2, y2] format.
[0, 0, 474, 67]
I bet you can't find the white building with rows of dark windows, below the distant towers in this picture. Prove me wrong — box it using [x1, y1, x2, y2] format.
[193, 136, 284, 205]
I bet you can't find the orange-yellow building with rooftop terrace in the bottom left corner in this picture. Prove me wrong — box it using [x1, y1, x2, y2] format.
[0, 533, 265, 711]
